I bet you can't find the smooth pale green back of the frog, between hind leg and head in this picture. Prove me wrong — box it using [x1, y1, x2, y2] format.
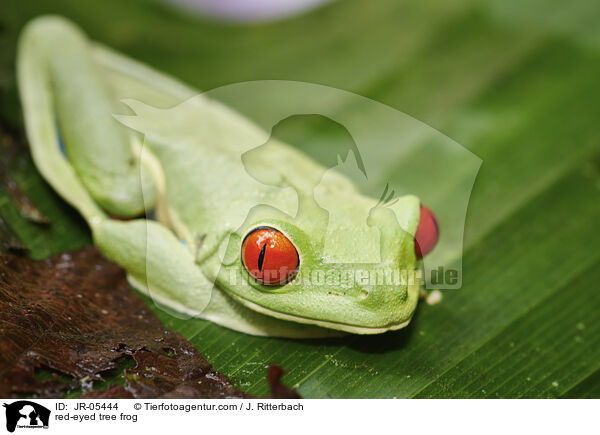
[119, 95, 357, 255]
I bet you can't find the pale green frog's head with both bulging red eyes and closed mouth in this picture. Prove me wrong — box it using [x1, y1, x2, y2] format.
[217, 172, 438, 334]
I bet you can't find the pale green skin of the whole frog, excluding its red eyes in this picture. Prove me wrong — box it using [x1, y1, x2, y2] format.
[18, 17, 420, 338]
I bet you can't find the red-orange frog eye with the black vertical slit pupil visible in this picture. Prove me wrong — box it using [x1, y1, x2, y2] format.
[242, 227, 300, 285]
